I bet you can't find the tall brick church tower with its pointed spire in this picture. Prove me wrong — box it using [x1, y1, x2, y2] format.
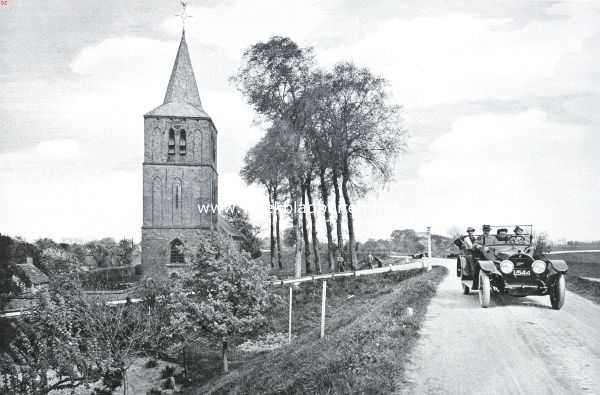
[142, 30, 219, 267]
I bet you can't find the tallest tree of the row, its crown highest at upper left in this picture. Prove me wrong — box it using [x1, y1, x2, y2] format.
[234, 36, 313, 277]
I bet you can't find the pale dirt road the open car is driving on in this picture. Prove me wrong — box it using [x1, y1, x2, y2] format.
[398, 259, 600, 395]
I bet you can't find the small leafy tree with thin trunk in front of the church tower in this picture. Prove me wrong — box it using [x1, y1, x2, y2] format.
[182, 234, 273, 372]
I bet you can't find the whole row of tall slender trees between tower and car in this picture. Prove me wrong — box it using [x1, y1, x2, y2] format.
[233, 37, 405, 276]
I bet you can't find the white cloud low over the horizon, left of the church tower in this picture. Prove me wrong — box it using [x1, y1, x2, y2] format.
[0, 140, 142, 240]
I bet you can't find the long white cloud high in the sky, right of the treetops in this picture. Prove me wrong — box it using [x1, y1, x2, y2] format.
[319, 14, 591, 108]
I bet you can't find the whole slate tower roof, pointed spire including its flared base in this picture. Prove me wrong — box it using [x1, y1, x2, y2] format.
[146, 30, 209, 118]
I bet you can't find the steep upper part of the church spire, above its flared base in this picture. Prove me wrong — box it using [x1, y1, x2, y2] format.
[163, 29, 202, 109]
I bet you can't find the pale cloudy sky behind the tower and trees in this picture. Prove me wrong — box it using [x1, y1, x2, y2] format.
[0, 0, 600, 241]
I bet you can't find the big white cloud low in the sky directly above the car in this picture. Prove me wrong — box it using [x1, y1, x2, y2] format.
[412, 110, 600, 237]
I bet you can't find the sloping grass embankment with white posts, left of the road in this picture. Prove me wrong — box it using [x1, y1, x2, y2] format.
[195, 267, 447, 394]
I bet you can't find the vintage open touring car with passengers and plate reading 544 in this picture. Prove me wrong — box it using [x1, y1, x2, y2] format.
[455, 225, 568, 310]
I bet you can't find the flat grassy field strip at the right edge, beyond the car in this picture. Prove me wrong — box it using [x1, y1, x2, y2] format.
[549, 252, 600, 304]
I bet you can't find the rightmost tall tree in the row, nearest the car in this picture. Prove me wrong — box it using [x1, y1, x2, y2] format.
[319, 62, 404, 266]
